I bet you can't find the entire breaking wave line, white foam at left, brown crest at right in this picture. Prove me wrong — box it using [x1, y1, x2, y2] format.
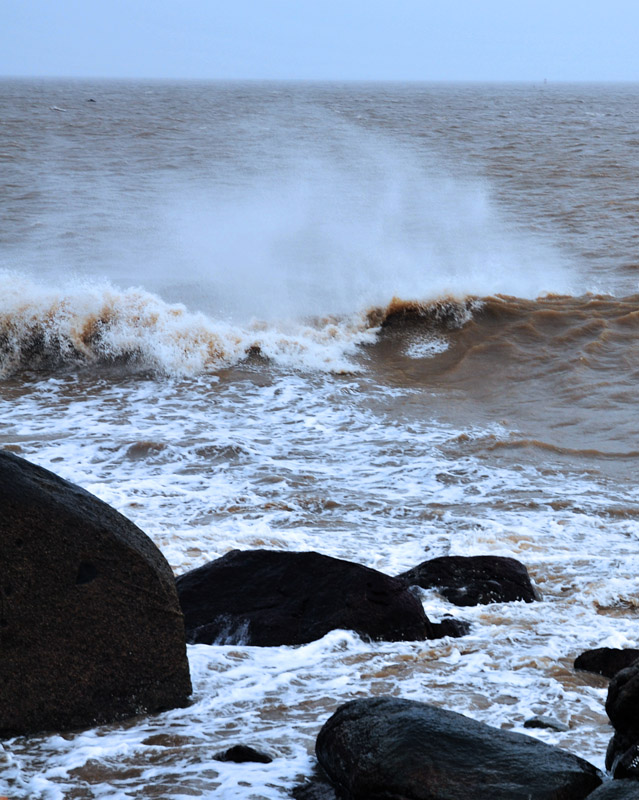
[0, 272, 639, 377]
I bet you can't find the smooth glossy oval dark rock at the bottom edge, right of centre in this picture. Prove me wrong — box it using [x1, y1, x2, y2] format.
[316, 697, 601, 800]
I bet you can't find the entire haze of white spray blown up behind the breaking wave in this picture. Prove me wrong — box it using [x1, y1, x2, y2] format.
[1, 84, 575, 323]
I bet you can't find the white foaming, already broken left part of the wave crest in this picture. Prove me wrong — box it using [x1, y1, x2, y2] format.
[0, 274, 388, 377]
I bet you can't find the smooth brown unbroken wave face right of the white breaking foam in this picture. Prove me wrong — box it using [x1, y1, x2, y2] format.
[374, 295, 639, 460]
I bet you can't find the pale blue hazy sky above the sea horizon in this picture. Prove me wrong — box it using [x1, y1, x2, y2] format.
[0, 0, 639, 81]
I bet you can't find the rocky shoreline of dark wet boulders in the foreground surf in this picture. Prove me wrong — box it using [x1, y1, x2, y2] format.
[0, 451, 639, 800]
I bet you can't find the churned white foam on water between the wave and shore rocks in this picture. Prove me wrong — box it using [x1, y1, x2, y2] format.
[0, 370, 639, 800]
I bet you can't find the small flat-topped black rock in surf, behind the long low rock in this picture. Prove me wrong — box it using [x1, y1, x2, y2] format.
[398, 556, 539, 606]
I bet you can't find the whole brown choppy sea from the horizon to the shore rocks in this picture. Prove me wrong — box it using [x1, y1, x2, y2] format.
[0, 79, 639, 800]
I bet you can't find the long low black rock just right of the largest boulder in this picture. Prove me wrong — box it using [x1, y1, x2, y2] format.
[177, 550, 436, 646]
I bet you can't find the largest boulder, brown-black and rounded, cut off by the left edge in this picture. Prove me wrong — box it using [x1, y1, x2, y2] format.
[0, 451, 191, 736]
